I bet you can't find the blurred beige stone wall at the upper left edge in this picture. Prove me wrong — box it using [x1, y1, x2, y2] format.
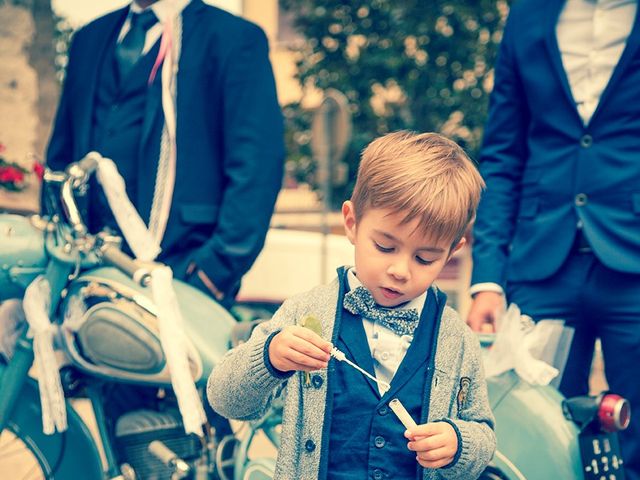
[0, 0, 58, 213]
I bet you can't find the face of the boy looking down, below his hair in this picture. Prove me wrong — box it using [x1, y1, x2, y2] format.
[342, 201, 465, 307]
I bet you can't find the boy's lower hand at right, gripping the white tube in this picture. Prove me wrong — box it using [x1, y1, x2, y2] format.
[404, 422, 458, 468]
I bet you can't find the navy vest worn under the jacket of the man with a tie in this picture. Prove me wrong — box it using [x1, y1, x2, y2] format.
[89, 29, 160, 231]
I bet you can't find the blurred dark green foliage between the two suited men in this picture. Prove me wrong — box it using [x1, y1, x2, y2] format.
[281, 0, 508, 204]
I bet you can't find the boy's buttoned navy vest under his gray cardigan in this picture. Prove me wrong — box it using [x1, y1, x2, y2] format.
[320, 271, 446, 480]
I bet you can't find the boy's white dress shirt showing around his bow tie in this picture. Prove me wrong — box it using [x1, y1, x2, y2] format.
[347, 268, 427, 395]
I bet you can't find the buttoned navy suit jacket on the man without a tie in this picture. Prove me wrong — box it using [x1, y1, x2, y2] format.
[472, 0, 640, 287]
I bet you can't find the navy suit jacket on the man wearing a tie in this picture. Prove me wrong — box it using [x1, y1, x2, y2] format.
[47, 0, 284, 300]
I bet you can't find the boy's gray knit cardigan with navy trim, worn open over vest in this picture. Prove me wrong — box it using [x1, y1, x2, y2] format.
[207, 279, 496, 480]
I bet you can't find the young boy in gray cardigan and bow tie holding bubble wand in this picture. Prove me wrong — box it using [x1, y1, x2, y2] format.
[207, 131, 495, 480]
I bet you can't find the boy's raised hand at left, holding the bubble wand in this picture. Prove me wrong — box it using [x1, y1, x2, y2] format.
[269, 325, 331, 372]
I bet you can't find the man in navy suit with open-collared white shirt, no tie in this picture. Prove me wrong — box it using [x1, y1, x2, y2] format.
[468, 0, 640, 472]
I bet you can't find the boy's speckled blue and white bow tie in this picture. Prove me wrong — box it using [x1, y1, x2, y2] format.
[343, 287, 420, 335]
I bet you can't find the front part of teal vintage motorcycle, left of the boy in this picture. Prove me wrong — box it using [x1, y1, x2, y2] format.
[0, 158, 279, 480]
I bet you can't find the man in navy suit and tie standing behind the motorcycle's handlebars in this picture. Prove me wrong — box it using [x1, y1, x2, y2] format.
[47, 0, 284, 306]
